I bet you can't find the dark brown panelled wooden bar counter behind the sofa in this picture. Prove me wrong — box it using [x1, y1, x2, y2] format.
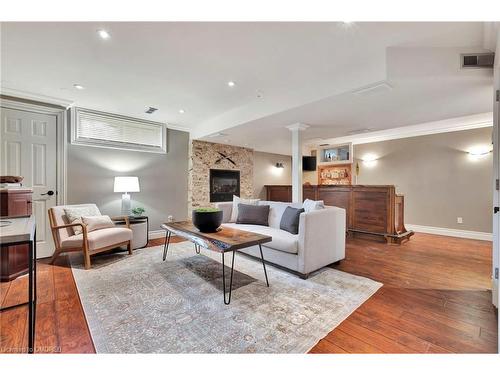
[265, 185, 414, 244]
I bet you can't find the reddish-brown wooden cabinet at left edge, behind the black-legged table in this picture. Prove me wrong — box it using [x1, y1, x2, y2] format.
[0, 188, 33, 282]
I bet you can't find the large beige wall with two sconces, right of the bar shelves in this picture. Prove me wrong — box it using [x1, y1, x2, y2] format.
[354, 128, 493, 233]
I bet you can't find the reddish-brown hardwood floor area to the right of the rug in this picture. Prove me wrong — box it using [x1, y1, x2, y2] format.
[311, 234, 498, 353]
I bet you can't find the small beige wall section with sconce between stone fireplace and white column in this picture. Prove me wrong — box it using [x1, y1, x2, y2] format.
[253, 151, 292, 199]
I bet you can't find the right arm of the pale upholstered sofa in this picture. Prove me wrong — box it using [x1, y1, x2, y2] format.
[298, 206, 346, 274]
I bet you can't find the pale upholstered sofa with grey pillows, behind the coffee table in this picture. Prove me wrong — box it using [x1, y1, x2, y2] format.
[216, 201, 346, 278]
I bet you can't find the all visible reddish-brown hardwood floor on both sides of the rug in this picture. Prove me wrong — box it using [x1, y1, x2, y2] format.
[0, 234, 497, 353]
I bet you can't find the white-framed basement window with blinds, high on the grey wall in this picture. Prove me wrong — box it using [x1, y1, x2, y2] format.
[71, 108, 167, 154]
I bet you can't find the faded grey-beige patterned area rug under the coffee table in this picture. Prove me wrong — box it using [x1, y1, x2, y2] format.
[71, 242, 382, 353]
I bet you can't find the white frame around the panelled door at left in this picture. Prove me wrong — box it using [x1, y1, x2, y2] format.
[0, 95, 69, 205]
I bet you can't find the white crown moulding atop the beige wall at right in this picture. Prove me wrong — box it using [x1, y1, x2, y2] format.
[307, 112, 493, 146]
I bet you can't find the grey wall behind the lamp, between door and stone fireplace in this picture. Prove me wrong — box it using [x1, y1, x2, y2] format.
[67, 129, 189, 230]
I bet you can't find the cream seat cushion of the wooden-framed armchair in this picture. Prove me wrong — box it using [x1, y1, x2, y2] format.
[61, 227, 132, 250]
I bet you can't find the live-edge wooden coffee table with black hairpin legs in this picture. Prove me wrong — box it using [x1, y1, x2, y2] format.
[161, 221, 272, 305]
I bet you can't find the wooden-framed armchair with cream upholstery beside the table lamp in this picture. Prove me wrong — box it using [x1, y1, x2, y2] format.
[48, 204, 132, 269]
